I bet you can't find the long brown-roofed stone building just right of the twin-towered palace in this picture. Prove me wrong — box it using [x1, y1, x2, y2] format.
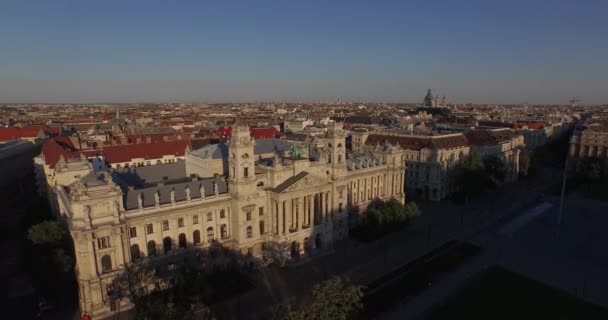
[352, 129, 524, 201]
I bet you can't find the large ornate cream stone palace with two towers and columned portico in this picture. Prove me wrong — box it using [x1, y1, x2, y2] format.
[37, 122, 405, 317]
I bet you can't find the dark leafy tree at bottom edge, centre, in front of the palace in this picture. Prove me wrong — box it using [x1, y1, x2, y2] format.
[274, 277, 363, 320]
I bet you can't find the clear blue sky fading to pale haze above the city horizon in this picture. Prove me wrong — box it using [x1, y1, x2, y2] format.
[0, 0, 608, 103]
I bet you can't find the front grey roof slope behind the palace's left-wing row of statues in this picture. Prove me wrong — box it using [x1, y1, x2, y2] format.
[124, 177, 228, 210]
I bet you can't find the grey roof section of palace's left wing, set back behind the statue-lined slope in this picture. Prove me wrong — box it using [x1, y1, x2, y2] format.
[113, 160, 188, 188]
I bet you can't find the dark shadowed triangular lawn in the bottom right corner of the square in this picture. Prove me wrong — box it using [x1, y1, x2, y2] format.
[427, 267, 608, 320]
